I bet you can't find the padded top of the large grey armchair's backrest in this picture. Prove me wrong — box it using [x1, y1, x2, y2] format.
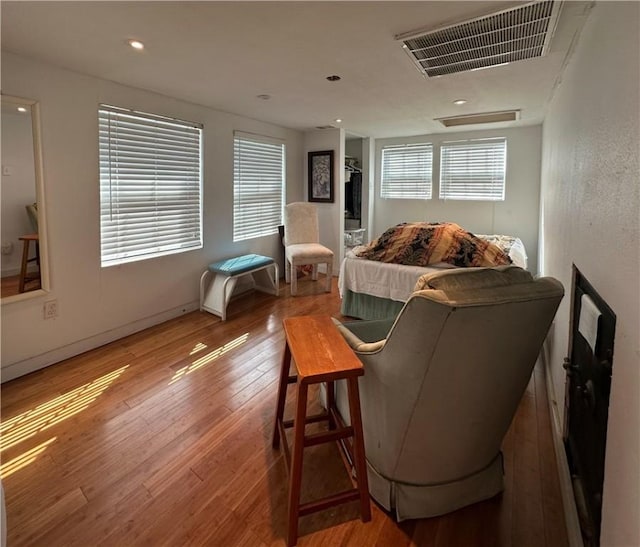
[413, 266, 533, 292]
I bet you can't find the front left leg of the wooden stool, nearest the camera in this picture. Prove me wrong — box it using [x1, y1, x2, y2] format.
[287, 382, 308, 547]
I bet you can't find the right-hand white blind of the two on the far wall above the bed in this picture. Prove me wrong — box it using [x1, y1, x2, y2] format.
[440, 138, 507, 201]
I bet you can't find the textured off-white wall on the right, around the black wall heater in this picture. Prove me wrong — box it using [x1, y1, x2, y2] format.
[541, 2, 640, 547]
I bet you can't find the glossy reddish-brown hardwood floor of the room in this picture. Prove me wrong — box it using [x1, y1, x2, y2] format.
[1, 280, 568, 547]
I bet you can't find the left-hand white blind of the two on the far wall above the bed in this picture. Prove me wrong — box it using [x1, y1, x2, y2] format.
[380, 144, 433, 199]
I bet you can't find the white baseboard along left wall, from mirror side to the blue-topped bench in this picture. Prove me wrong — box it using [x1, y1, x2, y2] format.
[0, 301, 200, 382]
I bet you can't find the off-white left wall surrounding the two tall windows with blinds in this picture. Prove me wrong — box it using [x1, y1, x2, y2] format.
[2, 52, 303, 381]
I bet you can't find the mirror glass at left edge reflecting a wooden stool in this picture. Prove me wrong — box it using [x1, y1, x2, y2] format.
[0, 96, 41, 298]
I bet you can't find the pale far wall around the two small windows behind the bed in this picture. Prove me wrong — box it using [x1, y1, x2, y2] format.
[370, 126, 542, 274]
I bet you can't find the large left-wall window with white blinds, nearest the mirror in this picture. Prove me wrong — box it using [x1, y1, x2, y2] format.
[98, 105, 202, 267]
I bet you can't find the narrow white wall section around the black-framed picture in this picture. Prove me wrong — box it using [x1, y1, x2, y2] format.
[301, 129, 345, 276]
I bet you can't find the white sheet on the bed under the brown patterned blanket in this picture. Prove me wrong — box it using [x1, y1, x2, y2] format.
[338, 236, 527, 302]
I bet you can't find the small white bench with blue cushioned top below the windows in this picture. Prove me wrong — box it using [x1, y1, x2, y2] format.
[200, 254, 279, 321]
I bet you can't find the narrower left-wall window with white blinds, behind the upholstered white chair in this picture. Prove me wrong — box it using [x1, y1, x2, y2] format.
[233, 132, 285, 241]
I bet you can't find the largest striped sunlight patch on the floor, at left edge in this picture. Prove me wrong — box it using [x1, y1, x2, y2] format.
[0, 365, 129, 452]
